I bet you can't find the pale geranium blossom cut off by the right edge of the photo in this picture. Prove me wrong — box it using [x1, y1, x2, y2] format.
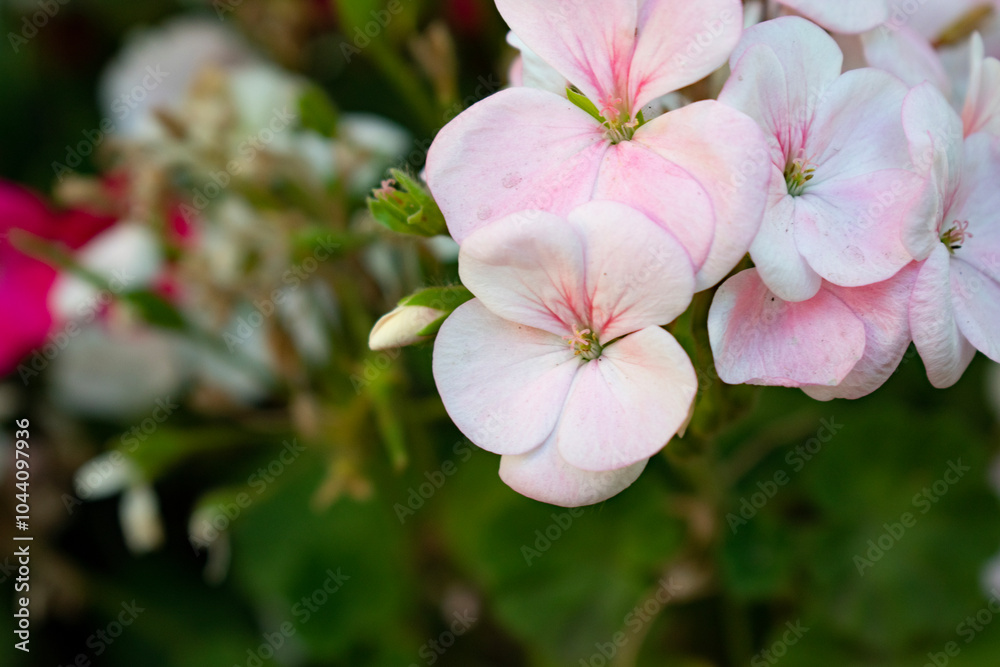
[904, 85, 1000, 387]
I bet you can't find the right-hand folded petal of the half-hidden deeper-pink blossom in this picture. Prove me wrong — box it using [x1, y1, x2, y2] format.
[802, 262, 920, 401]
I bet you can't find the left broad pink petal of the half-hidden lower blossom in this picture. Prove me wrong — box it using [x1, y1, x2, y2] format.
[708, 269, 865, 387]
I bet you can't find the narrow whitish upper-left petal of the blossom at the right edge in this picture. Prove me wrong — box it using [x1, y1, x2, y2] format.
[903, 83, 962, 261]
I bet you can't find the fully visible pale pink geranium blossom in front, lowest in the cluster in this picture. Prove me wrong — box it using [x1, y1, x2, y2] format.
[434, 202, 697, 506]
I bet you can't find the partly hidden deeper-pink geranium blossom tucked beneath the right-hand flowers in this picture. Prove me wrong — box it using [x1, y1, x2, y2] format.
[708, 263, 917, 400]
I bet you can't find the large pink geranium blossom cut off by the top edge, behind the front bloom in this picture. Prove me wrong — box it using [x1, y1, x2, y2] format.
[427, 0, 770, 289]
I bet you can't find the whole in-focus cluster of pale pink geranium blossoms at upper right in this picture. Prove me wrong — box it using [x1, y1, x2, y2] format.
[374, 0, 1000, 506]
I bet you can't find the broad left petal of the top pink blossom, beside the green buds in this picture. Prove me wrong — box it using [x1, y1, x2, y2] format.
[427, 88, 610, 243]
